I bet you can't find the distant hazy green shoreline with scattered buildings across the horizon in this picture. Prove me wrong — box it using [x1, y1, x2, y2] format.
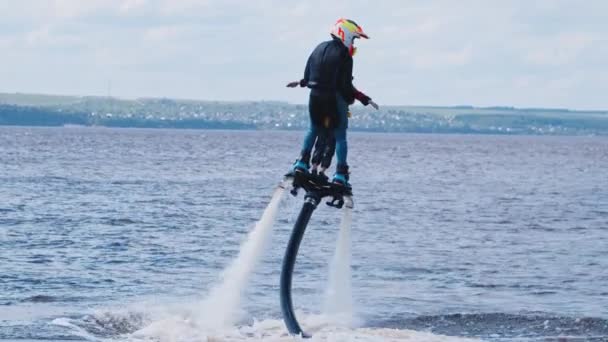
[0, 93, 608, 135]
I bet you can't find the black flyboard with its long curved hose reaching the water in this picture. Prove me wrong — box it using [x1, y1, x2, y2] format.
[280, 171, 353, 338]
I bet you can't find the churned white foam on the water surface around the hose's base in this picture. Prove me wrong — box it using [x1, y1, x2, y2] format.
[52, 305, 477, 342]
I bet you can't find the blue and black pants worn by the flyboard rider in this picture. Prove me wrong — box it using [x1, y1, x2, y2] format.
[301, 94, 348, 170]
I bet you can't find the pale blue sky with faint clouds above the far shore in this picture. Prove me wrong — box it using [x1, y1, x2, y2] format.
[0, 0, 608, 109]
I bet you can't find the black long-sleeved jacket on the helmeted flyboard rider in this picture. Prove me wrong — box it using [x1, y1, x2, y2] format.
[300, 38, 355, 104]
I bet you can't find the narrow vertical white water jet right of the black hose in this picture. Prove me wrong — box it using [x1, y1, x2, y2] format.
[323, 207, 355, 327]
